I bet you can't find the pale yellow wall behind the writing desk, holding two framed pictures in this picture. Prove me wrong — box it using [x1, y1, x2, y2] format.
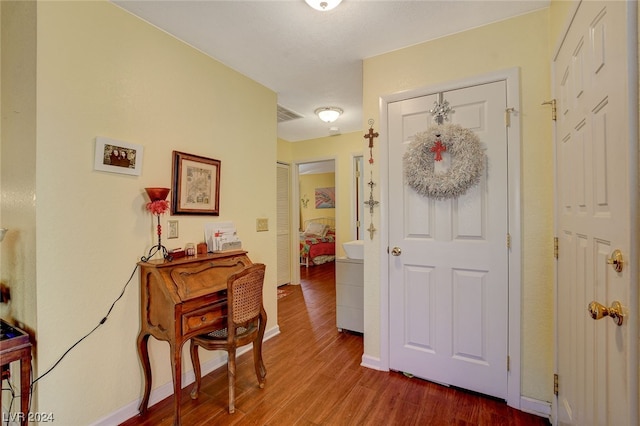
[2, 1, 277, 426]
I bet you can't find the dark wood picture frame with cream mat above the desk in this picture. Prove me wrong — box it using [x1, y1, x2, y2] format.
[171, 151, 221, 216]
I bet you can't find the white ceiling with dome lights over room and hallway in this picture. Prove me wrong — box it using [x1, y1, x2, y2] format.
[112, 0, 549, 142]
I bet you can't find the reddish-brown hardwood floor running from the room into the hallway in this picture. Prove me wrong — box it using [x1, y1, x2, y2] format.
[123, 263, 549, 426]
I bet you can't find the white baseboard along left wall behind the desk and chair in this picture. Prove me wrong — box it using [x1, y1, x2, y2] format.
[91, 325, 280, 426]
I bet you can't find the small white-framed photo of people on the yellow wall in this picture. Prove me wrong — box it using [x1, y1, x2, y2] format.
[93, 136, 144, 176]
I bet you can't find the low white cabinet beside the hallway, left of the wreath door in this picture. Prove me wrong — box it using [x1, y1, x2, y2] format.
[336, 258, 364, 333]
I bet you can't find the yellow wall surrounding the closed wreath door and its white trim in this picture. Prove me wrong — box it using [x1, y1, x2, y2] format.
[363, 9, 554, 401]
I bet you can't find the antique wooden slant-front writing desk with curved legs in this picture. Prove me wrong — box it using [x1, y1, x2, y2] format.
[138, 250, 252, 425]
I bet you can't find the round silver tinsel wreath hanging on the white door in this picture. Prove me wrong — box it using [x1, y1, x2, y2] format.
[403, 124, 485, 200]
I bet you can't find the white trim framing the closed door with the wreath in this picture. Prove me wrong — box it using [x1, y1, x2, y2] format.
[379, 68, 522, 409]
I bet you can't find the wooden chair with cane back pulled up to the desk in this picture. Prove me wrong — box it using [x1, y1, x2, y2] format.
[190, 263, 267, 413]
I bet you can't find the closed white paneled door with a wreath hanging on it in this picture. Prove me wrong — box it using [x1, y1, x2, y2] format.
[388, 76, 509, 399]
